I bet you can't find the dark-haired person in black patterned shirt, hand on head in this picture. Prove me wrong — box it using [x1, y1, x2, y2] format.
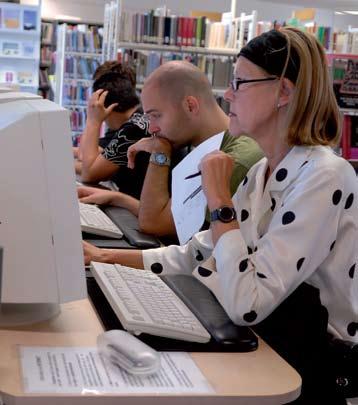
[76, 61, 149, 198]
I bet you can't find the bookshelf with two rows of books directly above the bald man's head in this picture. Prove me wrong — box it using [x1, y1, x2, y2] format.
[103, 0, 257, 110]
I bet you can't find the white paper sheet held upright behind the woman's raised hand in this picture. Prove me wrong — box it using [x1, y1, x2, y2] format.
[171, 132, 224, 245]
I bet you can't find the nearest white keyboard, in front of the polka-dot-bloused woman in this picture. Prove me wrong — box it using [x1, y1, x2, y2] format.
[92, 262, 210, 343]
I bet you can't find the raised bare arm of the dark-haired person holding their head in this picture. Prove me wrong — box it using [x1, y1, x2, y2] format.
[76, 90, 118, 183]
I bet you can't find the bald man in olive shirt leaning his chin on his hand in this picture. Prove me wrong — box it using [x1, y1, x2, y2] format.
[79, 61, 262, 236]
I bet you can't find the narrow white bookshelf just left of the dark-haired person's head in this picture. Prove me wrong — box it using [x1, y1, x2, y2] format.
[55, 23, 102, 145]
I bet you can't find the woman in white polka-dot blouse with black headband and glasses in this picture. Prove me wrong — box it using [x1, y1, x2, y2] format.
[84, 28, 358, 405]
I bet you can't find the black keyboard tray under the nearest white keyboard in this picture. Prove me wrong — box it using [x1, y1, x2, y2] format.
[87, 276, 258, 352]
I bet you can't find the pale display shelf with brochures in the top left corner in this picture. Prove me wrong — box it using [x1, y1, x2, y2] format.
[0, 2, 41, 93]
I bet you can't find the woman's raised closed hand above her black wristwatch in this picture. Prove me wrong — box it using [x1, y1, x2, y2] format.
[199, 151, 234, 210]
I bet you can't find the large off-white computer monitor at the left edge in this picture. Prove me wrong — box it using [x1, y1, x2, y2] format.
[0, 92, 87, 325]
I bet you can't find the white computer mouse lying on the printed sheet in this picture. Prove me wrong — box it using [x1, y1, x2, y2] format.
[97, 330, 160, 375]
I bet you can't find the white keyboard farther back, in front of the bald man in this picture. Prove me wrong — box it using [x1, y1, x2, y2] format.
[79, 202, 123, 239]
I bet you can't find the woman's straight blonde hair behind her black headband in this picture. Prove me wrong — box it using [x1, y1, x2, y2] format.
[280, 27, 341, 146]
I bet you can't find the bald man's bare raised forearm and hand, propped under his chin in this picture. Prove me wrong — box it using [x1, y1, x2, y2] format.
[128, 137, 176, 236]
